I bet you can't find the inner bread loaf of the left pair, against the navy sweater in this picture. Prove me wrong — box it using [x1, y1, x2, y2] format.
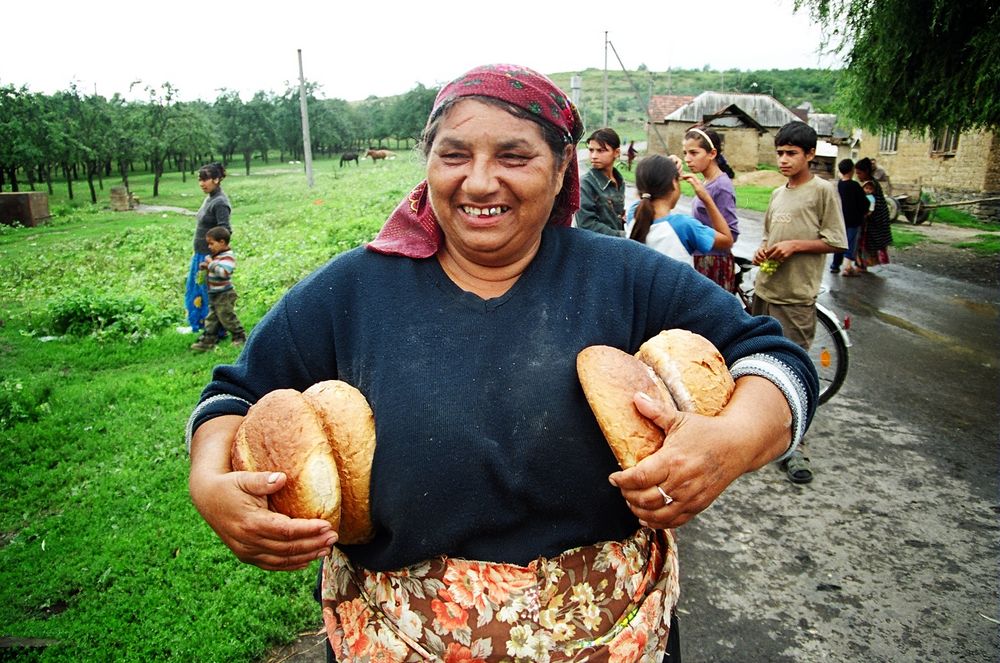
[302, 380, 375, 543]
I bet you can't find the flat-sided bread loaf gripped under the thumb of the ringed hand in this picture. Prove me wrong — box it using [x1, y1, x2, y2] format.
[576, 345, 671, 468]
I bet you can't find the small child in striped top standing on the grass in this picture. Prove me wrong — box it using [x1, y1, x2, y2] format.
[191, 226, 246, 352]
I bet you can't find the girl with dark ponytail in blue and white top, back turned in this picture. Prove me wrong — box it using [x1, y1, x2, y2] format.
[626, 154, 733, 266]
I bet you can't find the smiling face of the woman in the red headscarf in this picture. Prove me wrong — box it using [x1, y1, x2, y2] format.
[427, 99, 569, 267]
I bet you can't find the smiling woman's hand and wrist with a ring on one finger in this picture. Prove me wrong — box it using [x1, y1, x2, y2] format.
[609, 376, 791, 529]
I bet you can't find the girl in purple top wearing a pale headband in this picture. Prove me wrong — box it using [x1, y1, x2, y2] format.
[684, 127, 740, 292]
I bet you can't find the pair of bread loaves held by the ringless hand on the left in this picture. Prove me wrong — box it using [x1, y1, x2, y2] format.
[232, 380, 375, 544]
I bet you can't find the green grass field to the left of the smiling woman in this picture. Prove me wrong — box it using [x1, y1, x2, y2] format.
[0, 153, 422, 661]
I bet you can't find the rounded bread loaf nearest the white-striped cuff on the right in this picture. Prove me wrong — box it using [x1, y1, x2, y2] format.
[635, 329, 736, 417]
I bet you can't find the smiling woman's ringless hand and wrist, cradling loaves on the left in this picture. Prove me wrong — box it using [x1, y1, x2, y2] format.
[188, 416, 337, 571]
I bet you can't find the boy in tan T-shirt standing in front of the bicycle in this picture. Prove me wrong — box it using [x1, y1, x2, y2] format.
[751, 121, 847, 483]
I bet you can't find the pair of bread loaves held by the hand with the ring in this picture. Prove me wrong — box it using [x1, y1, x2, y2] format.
[576, 329, 735, 468]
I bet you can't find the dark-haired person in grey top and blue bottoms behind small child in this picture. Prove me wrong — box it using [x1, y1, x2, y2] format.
[184, 162, 233, 334]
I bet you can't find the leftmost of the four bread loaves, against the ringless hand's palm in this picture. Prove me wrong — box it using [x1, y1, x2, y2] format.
[232, 389, 341, 530]
